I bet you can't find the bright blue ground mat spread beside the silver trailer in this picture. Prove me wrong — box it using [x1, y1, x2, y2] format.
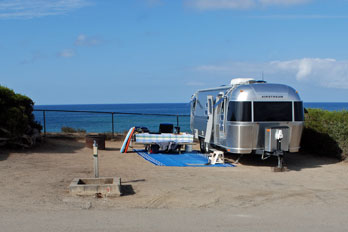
[135, 150, 235, 167]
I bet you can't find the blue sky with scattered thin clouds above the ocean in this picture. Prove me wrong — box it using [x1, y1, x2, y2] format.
[0, 0, 348, 105]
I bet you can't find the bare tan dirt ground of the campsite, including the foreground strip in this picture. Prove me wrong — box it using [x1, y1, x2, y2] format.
[0, 138, 348, 231]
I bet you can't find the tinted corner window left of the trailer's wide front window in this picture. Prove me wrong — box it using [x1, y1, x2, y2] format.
[227, 101, 251, 122]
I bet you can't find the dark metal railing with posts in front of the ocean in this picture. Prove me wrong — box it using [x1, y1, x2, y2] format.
[34, 109, 190, 138]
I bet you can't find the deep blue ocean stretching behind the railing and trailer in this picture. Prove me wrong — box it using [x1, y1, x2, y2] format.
[34, 102, 348, 133]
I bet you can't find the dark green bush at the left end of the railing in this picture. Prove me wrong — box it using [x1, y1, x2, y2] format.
[0, 85, 42, 145]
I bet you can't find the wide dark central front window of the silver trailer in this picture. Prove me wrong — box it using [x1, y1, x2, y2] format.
[254, 102, 292, 122]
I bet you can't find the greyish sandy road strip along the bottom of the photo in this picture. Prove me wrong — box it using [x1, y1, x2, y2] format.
[0, 206, 347, 232]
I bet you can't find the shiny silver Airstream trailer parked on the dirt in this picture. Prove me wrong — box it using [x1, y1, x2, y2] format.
[190, 78, 304, 168]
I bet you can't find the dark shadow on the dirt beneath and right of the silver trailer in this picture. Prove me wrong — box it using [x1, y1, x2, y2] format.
[225, 153, 340, 171]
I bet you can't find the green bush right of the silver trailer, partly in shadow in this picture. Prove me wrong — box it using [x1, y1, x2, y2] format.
[301, 109, 348, 159]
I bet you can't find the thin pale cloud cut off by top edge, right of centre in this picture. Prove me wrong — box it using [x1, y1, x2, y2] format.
[185, 0, 312, 10]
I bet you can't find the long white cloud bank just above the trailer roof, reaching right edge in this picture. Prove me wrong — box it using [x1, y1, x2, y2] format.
[195, 58, 348, 89]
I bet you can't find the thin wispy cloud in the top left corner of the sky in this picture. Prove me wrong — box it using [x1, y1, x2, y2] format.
[0, 0, 90, 19]
